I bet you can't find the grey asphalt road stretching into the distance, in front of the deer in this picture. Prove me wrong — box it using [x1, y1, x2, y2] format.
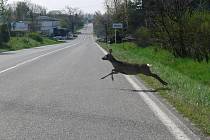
[0, 25, 199, 140]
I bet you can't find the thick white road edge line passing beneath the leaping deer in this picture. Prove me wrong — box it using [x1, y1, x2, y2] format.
[95, 43, 194, 140]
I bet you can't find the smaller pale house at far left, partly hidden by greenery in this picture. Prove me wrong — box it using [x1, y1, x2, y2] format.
[11, 21, 29, 32]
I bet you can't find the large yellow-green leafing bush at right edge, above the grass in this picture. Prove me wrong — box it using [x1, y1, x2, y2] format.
[153, 11, 210, 62]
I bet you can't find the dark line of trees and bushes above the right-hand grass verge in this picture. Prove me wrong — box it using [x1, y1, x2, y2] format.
[93, 0, 210, 62]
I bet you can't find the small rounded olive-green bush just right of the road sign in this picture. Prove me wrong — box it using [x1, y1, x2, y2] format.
[135, 27, 151, 47]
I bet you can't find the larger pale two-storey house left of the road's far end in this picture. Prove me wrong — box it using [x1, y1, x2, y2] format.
[37, 16, 60, 36]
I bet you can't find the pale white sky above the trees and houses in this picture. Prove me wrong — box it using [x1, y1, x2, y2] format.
[8, 0, 104, 13]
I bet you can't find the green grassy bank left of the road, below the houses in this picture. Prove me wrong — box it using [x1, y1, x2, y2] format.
[0, 37, 63, 52]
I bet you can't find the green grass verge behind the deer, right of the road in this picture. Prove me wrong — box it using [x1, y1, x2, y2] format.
[100, 43, 210, 135]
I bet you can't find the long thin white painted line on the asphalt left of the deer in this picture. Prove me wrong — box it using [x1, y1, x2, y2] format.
[0, 43, 80, 74]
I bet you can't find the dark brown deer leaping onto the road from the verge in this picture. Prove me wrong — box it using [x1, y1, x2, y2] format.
[101, 49, 168, 85]
